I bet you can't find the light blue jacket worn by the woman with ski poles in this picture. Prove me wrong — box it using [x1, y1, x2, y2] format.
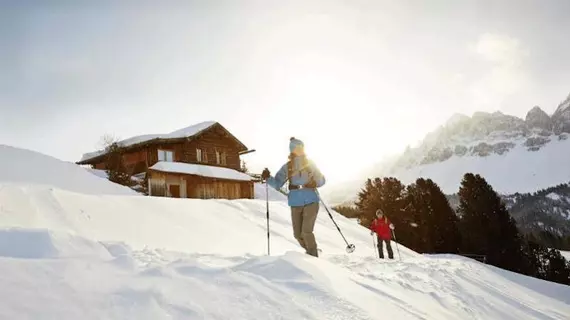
[267, 157, 325, 207]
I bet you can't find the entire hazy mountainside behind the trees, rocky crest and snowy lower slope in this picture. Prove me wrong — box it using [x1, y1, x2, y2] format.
[327, 95, 570, 208]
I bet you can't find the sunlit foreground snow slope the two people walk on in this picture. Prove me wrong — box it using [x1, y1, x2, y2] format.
[0, 144, 570, 320]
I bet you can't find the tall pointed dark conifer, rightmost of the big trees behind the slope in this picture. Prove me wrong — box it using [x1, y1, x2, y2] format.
[459, 173, 524, 272]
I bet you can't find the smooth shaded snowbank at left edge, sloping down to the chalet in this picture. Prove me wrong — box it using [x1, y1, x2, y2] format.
[0, 144, 137, 195]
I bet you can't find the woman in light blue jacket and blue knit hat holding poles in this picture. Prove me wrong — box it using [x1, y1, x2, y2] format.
[261, 137, 325, 257]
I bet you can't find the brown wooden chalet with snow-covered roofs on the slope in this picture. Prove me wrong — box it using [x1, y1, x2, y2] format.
[77, 122, 254, 199]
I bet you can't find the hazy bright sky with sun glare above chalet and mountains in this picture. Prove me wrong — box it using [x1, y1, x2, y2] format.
[0, 0, 570, 182]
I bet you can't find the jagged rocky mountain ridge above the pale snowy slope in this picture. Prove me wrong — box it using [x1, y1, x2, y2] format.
[388, 95, 570, 172]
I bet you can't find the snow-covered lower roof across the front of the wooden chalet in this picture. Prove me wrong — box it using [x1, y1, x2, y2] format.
[149, 161, 253, 181]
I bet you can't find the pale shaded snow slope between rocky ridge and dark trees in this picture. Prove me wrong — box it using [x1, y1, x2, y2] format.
[388, 137, 570, 194]
